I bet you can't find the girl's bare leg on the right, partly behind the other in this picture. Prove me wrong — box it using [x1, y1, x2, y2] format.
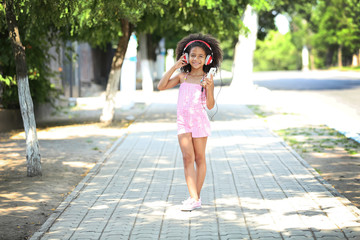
[193, 137, 207, 198]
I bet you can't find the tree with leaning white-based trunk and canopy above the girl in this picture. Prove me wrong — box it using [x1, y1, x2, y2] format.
[73, 0, 255, 123]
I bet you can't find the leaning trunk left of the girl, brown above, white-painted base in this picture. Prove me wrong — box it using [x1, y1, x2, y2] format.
[100, 19, 132, 124]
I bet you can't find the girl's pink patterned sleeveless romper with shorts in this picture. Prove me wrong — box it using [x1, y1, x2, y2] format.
[177, 77, 210, 138]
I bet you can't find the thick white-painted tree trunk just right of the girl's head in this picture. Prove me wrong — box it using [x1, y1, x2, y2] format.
[231, 5, 258, 91]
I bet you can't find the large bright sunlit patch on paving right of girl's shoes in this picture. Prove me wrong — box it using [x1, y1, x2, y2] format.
[216, 193, 360, 231]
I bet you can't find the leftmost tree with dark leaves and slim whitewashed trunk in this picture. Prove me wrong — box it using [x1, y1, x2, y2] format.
[0, 0, 74, 176]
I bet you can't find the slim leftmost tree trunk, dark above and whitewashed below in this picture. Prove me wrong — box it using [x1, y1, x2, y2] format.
[3, 0, 42, 177]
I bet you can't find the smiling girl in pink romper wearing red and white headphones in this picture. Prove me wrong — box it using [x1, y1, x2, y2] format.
[158, 34, 222, 211]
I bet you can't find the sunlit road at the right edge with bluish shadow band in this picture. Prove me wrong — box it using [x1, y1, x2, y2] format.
[253, 71, 360, 140]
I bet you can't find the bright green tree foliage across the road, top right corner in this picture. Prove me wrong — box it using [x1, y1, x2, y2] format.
[258, 0, 360, 68]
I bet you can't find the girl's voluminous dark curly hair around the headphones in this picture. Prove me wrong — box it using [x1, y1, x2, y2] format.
[176, 34, 223, 73]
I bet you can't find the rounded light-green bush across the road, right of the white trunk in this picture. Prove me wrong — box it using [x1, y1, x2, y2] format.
[254, 30, 299, 71]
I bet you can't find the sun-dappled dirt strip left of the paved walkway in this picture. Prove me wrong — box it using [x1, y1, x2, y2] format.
[0, 121, 131, 238]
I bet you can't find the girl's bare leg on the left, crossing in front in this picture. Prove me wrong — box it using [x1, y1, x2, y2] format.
[178, 133, 199, 201]
